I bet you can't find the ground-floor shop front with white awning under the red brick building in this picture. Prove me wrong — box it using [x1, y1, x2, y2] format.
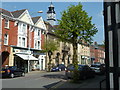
[13, 47, 39, 73]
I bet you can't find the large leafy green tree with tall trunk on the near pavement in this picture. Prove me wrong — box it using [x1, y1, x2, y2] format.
[55, 3, 98, 81]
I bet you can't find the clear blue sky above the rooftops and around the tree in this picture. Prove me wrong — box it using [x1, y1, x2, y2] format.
[2, 2, 104, 44]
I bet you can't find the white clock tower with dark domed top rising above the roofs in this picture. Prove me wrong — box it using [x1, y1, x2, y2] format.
[47, 2, 56, 26]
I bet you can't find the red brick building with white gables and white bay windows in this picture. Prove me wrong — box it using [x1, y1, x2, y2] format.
[0, 9, 46, 71]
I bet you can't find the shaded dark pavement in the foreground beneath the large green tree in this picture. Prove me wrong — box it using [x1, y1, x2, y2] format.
[51, 76, 106, 90]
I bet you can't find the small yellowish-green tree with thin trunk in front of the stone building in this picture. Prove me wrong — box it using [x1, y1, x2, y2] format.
[44, 39, 58, 71]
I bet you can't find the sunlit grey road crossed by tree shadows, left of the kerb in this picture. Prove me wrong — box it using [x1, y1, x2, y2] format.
[2, 72, 64, 88]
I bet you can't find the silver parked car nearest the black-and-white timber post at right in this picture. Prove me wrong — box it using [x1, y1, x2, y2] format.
[91, 64, 105, 74]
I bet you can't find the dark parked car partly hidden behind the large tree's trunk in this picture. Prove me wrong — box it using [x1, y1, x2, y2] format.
[65, 64, 95, 79]
